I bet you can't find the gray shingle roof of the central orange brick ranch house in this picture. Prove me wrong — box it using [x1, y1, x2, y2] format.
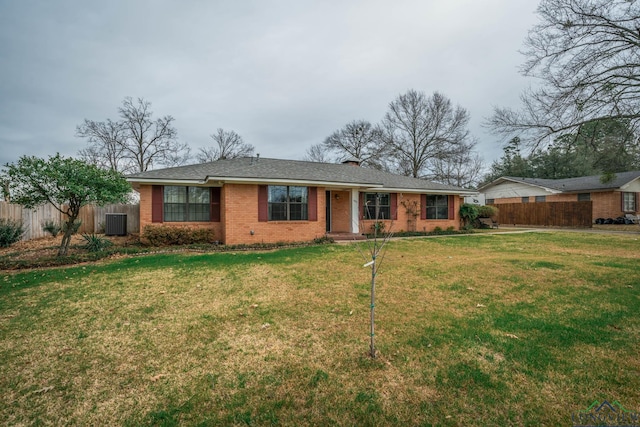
[127, 157, 471, 193]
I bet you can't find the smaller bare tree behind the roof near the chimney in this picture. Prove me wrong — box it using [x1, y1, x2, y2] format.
[322, 120, 387, 169]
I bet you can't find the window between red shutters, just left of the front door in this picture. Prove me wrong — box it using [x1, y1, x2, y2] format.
[268, 185, 309, 221]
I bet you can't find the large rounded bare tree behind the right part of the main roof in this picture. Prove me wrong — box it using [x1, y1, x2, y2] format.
[382, 90, 469, 178]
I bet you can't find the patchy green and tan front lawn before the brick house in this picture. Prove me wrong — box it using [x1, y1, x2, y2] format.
[0, 232, 640, 426]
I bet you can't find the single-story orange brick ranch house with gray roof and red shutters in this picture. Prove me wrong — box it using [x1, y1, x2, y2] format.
[127, 157, 475, 245]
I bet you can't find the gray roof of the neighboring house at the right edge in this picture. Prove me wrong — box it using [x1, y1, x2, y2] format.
[480, 171, 640, 193]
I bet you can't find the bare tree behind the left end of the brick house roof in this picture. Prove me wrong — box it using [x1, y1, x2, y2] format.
[76, 97, 190, 172]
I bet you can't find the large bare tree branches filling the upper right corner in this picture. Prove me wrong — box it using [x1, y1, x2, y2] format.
[485, 0, 640, 148]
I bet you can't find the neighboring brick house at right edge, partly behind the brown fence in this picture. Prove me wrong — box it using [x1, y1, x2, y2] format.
[478, 171, 640, 221]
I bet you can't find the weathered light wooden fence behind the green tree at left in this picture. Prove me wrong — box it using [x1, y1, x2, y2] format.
[0, 202, 140, 240]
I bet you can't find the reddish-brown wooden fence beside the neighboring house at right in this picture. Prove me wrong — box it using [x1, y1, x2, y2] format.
[495, 201, 592, 227]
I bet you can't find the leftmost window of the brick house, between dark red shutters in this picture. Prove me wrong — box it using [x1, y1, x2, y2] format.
[164, 185, 210, 222]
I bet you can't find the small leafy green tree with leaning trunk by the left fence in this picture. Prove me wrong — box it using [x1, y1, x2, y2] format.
[6, 154, 131, 256]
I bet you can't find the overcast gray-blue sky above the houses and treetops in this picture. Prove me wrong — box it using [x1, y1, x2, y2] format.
[0, 0, 538, 171]
